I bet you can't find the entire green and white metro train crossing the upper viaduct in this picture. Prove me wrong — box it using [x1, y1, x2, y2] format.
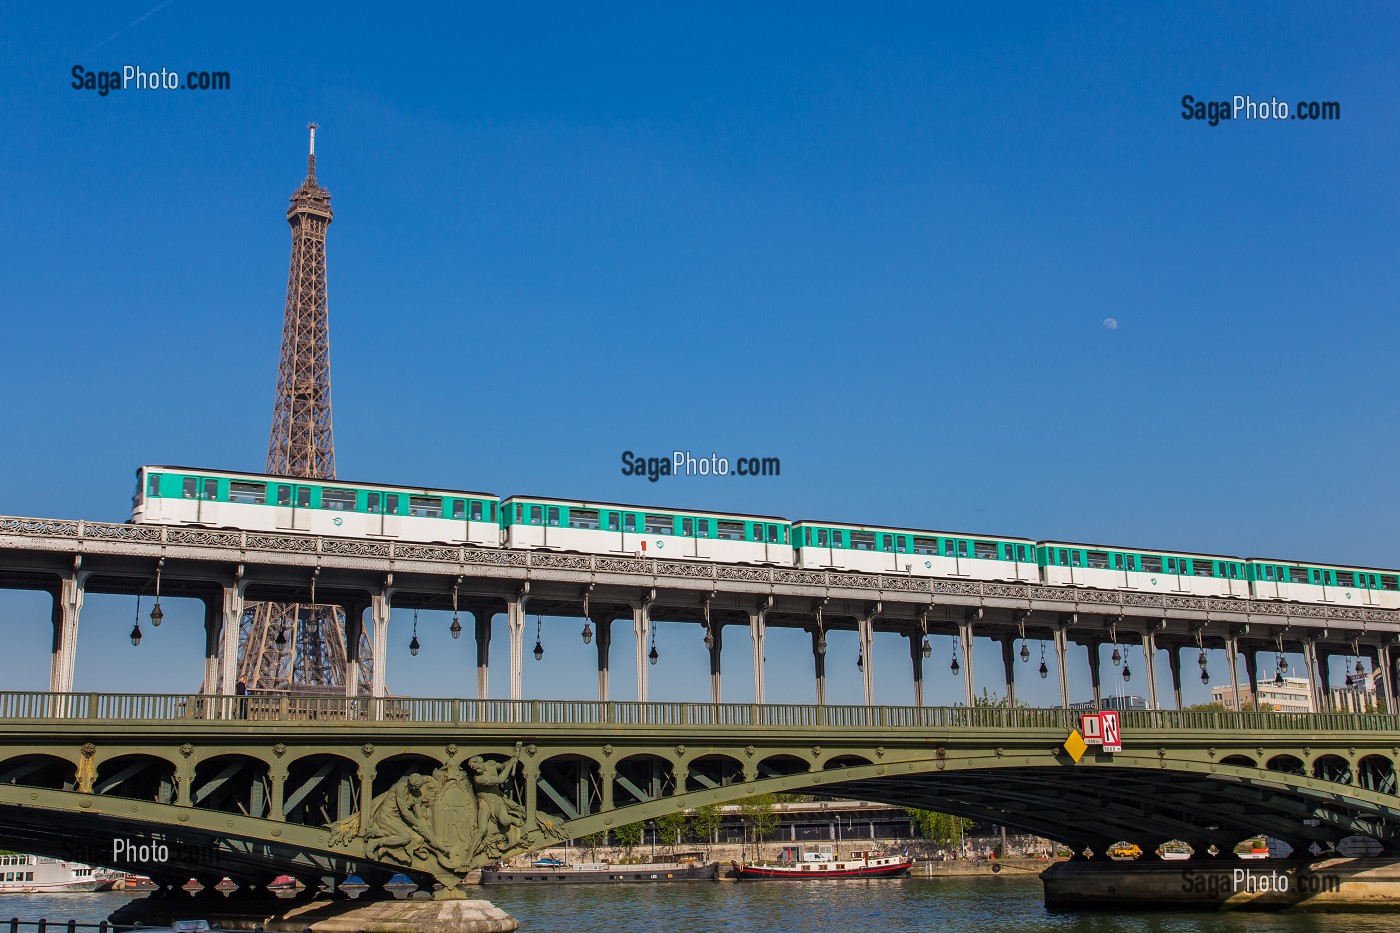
[132, 465, 1400, 609]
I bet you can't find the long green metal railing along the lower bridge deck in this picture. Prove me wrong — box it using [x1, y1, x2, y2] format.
[0, 692, 1400, 733]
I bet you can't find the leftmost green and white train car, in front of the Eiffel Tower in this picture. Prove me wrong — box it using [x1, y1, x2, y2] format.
[132, 465, 501, 548]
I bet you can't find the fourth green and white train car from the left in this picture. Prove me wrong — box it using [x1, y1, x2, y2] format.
[1036, 541, 1250, 600]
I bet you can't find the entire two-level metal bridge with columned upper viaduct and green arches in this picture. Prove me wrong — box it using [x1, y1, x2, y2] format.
[0, 518, 1400, 887]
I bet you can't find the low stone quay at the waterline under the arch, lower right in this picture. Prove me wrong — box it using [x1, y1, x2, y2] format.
[1040, 857, 1400, 911]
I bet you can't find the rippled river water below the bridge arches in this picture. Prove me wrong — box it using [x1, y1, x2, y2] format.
[8, 877, 1400, 933]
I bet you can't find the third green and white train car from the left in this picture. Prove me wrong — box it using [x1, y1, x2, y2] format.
[792, 521, 1040, 583]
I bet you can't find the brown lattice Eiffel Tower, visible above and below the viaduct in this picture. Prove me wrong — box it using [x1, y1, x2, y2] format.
[220, 123, 374, 696]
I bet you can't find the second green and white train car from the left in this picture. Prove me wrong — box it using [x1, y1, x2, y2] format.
[501, 496, 792, 567]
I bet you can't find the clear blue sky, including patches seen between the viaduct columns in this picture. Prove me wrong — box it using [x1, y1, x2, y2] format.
[0, 0, 1400, 702]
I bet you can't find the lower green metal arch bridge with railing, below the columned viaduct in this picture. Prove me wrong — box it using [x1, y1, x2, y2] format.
[0, 693, 1400, 888]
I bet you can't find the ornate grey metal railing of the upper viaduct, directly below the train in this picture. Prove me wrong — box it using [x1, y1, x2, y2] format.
[0, 517, 1400, 623]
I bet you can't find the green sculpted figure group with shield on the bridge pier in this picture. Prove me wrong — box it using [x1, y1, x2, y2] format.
[329, 744, 564, 888]
